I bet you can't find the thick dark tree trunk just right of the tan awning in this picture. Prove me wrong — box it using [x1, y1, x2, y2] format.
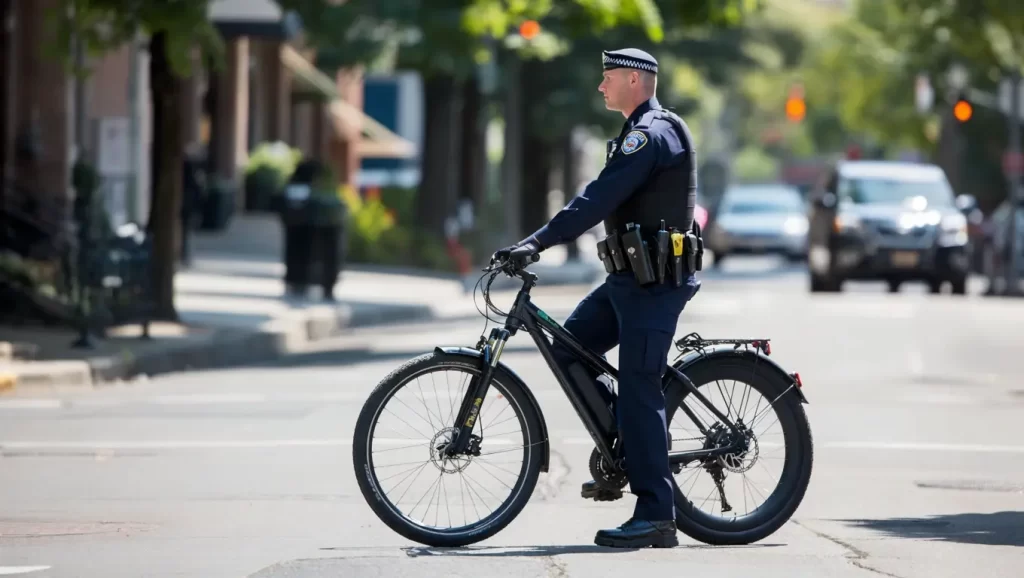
[416, 74, 461, 237]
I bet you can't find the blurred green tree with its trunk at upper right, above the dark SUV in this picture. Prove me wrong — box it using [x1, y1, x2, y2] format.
[802, 0, 1024, 206]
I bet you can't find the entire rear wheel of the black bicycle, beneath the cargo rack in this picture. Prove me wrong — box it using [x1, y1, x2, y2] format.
[666, 357, 813, 545]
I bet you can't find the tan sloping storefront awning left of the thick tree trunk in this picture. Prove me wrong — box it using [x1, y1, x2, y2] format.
[281, 45, 416, 159]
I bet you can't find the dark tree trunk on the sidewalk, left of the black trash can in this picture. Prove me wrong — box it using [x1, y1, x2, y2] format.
[148, 32, 184, 321]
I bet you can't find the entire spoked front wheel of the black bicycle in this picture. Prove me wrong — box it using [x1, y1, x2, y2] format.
[352, 353, 545, 547]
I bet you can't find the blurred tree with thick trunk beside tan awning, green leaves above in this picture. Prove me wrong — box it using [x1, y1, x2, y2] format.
[283, 0, 679, 239]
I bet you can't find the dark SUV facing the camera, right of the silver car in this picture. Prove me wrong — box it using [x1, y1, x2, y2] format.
[808, 161, 970, 295]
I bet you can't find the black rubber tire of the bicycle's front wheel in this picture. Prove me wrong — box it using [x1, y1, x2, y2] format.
[352, 352, 544, 547]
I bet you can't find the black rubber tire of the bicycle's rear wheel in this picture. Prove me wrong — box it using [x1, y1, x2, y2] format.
[666, 357, 814, 545]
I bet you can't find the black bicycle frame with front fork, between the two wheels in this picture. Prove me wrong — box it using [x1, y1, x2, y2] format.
[445, 271, 740, 467]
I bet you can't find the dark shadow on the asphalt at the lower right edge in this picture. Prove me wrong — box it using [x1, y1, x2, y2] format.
[840, 511, 1024, 546]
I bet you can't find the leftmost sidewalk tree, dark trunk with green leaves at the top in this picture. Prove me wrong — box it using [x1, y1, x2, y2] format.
[56, 0, 222, 321]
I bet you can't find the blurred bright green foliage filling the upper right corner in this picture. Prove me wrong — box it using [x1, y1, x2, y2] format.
[803, 0, 1024, 157]
